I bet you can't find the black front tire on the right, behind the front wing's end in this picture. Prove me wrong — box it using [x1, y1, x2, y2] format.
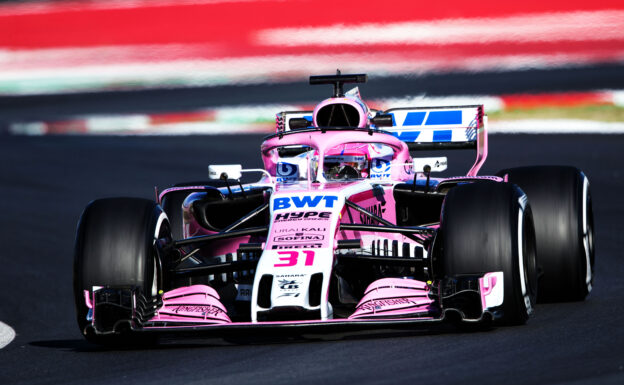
[440, 182, 537, 325]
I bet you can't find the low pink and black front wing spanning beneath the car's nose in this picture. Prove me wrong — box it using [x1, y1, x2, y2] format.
[80, 272, 504, 336]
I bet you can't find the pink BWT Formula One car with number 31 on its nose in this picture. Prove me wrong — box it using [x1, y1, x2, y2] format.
[74, 73, 594, 343]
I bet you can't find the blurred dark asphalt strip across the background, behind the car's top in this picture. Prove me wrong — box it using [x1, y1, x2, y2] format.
[0, 63, 624, 124]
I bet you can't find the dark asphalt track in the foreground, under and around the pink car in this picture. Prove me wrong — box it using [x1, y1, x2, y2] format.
[0, 131, 624, 385]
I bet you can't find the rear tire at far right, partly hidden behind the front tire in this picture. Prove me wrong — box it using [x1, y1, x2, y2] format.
[498, 166, 595, 302]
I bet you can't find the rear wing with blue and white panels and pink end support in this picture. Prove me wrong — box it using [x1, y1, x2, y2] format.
[383, 105, 488, 176]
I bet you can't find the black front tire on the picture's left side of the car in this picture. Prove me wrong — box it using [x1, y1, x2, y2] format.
[74, 198, 171, 344]
